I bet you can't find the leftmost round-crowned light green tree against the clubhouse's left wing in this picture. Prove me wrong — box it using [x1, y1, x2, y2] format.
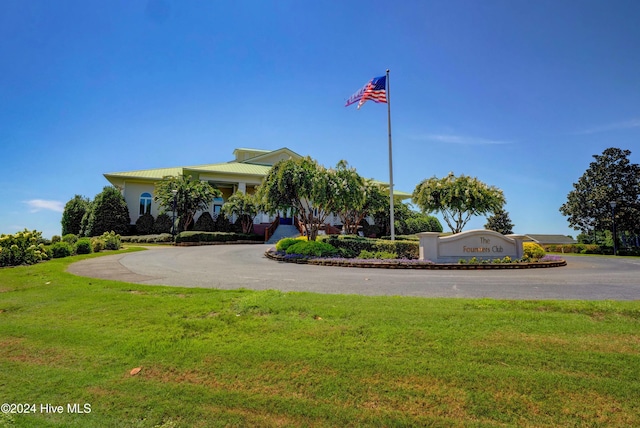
[154, 174, 222, 230]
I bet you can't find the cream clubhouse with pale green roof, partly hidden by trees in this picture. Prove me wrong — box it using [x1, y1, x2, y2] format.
[104, 147, 411, 233]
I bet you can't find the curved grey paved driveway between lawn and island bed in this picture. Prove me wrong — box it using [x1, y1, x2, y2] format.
[69, 245, 640, 300]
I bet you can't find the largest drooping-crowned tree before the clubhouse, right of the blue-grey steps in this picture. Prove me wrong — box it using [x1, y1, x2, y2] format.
[258, 156, 338, 241]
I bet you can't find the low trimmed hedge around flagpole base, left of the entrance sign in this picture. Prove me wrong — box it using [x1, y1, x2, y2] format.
[318, 235, 420, 259]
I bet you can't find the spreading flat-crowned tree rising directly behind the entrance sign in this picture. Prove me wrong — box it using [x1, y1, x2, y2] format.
[413, 172, 506, 233]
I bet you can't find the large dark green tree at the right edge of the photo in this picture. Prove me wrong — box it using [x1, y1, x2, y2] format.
[560, 147, 640, 234]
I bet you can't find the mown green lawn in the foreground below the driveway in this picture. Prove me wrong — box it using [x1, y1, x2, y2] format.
[0, 249, 640, 427]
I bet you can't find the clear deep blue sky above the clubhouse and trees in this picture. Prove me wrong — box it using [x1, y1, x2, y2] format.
[0, 0, 640, 237]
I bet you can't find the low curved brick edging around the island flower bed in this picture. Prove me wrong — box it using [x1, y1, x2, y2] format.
[264, 250, 567, 270]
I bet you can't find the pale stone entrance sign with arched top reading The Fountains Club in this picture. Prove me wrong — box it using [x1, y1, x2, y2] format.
[418, 230, 526, 263]
